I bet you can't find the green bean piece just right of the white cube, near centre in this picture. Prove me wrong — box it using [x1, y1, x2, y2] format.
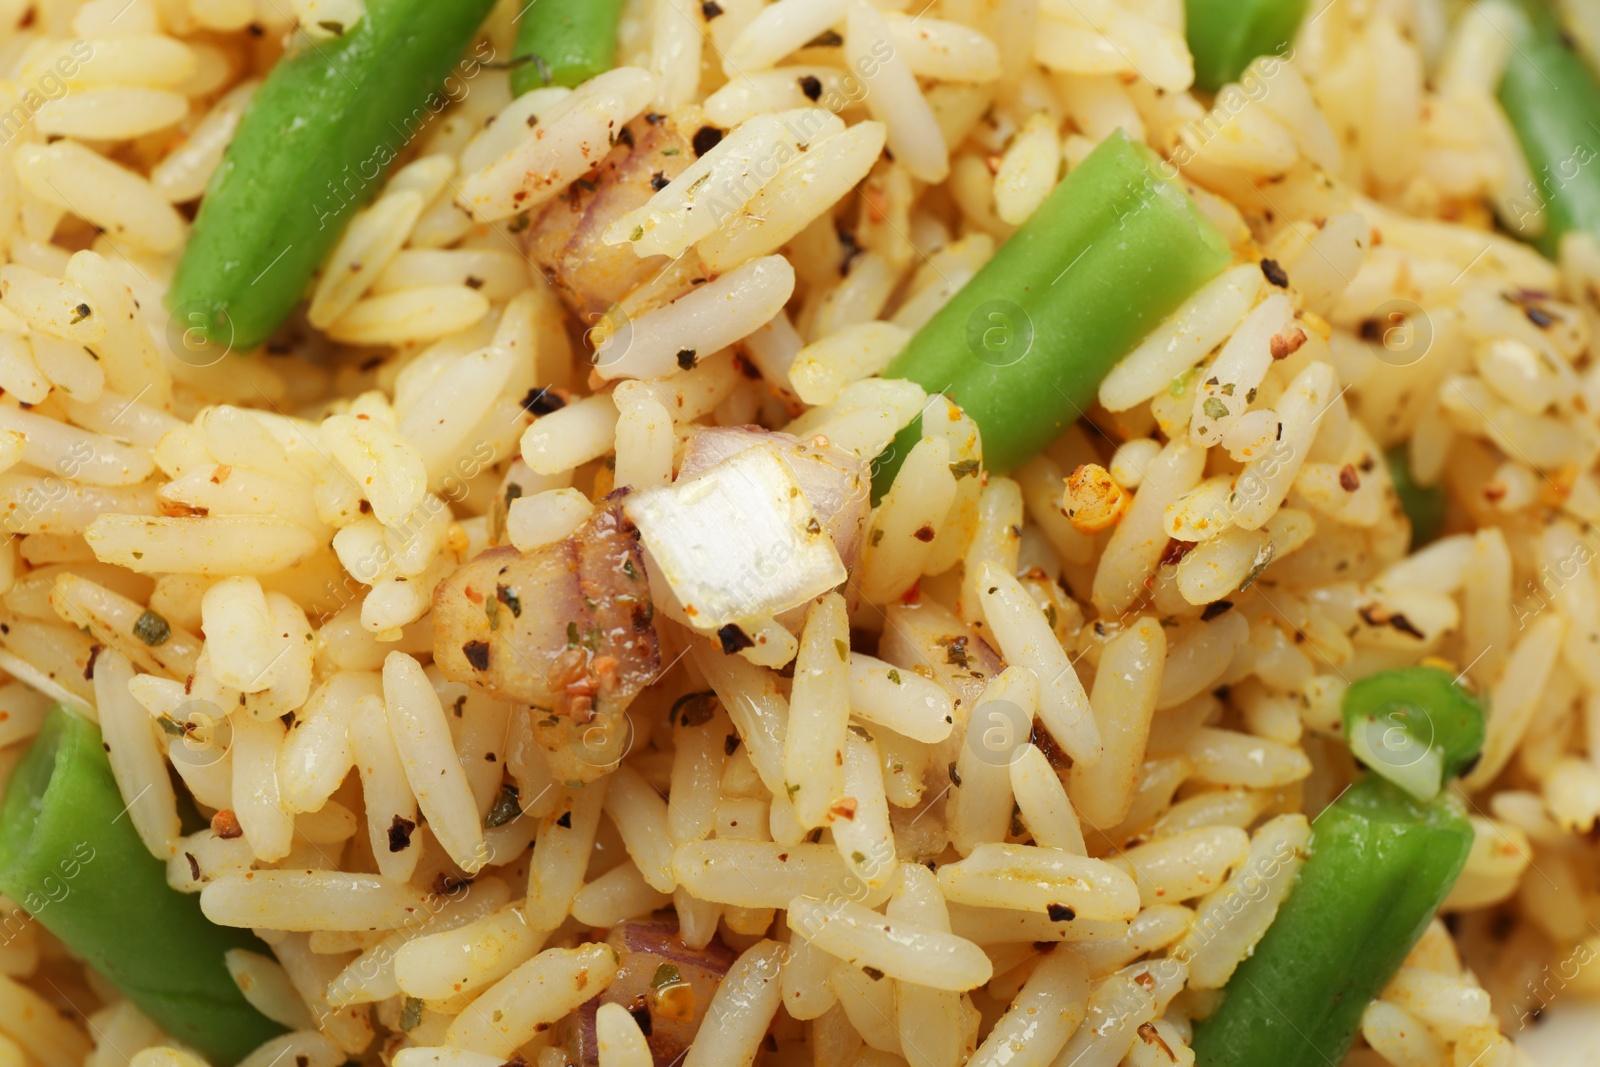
[874, 131, 1232, 494]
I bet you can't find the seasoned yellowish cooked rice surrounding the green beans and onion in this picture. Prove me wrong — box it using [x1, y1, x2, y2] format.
[0, 0, 1580, 1067]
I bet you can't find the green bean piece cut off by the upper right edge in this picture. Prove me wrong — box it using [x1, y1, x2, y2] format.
[1499, 0, 1600, 259]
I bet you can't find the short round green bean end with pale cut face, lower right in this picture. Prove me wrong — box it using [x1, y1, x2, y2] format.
[1344, 667, 1483, 800]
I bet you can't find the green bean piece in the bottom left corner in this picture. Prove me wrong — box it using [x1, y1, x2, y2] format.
[0, 707, 283, 1065]
